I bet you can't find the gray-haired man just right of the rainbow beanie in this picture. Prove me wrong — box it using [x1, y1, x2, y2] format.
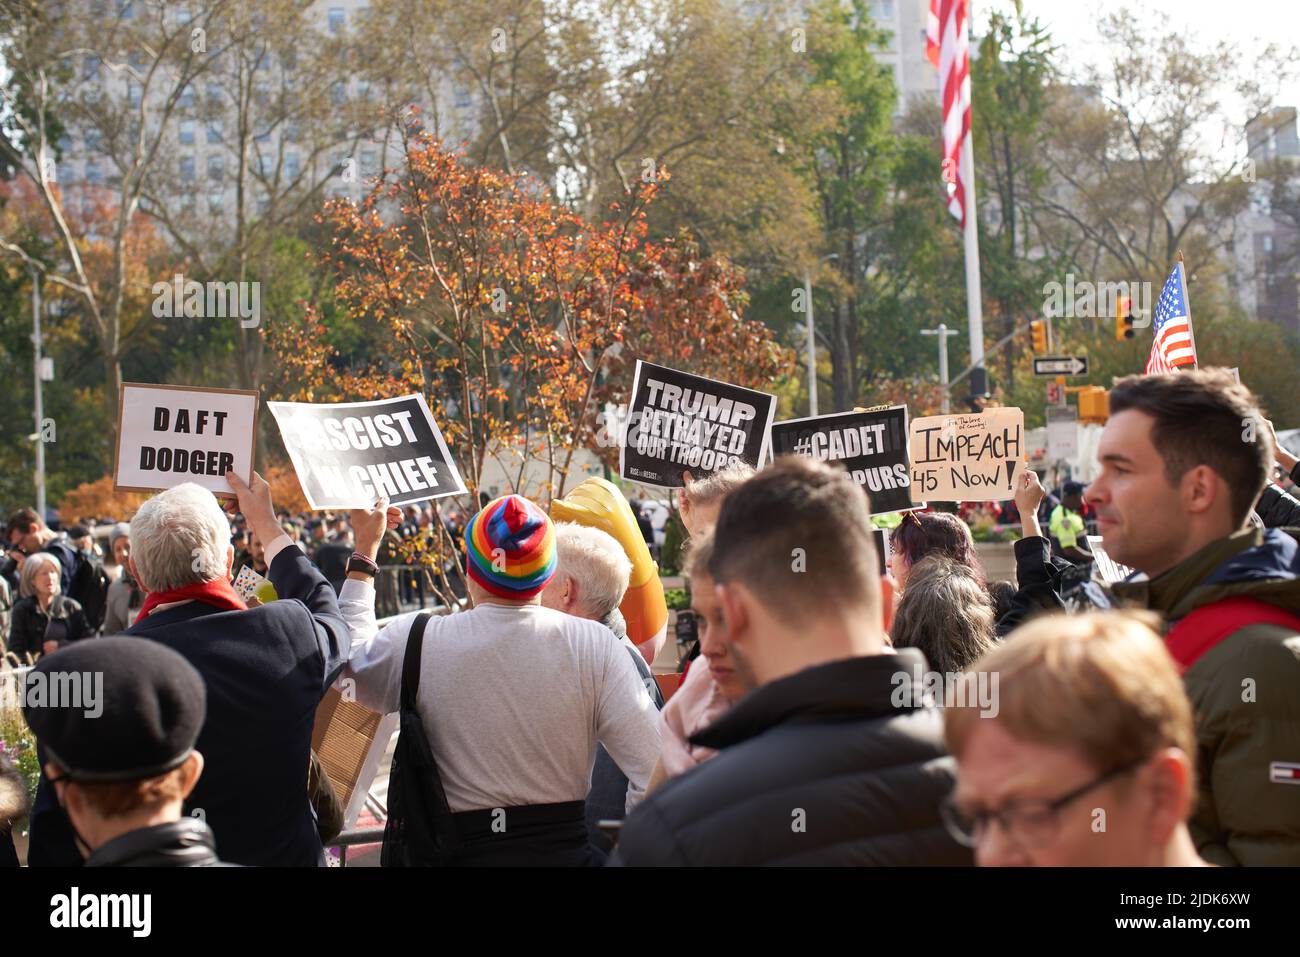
[542, 521, 664, 853]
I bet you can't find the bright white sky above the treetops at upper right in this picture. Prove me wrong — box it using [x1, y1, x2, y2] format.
[987, 0, 1300, 127]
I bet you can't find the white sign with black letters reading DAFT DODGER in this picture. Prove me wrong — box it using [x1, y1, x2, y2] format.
[113, 382, 259, 498]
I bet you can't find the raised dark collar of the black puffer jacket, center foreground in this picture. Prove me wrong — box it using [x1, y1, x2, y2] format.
[690, 648, 926, 749]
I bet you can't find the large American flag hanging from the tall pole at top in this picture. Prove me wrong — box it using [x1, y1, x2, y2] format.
[926, 0, 971, 226]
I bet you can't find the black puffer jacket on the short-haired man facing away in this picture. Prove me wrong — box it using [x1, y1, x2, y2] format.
[614, 649, 971, 866]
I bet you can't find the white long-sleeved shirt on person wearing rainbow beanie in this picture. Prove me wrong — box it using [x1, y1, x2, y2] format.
[339, 579, 659, 813]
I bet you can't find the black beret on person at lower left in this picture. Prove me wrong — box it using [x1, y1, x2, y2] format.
[23, 635, 208, 781]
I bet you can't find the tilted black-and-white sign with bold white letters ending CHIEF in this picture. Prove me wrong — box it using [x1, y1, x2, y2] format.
[267, 395, 465, 508]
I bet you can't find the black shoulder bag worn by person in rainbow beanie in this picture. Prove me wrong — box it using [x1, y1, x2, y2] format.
[380, 612, 460, 867]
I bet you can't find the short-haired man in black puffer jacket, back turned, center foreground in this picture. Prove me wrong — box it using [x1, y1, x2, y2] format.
[615, 456, 971, 866]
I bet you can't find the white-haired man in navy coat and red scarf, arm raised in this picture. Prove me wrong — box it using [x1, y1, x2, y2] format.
[24, 472, 385, 866]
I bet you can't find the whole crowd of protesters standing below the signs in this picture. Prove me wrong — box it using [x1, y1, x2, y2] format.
[0, 371, 1300, 866]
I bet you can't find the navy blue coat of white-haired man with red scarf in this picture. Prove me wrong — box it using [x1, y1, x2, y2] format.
[31, 546, 351, 866]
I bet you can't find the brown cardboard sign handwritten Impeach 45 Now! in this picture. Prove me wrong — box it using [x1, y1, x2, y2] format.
[911, 408, 1024, 502]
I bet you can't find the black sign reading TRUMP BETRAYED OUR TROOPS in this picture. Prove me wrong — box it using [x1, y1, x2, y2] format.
[619, 359, 776, 489]
